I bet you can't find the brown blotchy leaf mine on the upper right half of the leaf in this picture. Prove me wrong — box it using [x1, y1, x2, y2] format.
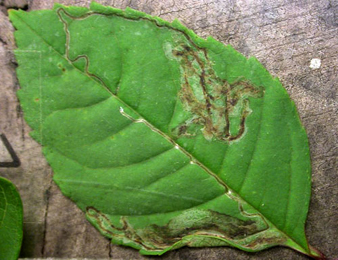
[172, 43, 264, 141]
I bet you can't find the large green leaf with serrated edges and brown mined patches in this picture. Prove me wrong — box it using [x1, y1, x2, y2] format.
[10, 3, 321, 258]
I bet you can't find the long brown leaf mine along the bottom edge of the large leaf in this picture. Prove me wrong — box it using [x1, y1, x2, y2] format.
[86, 207, 285, 253]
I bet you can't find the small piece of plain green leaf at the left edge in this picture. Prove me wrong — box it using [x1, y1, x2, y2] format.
[0, 177, 23, 260]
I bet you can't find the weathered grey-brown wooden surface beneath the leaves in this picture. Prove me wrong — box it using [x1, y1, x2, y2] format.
[0, 0, 338, 260]
